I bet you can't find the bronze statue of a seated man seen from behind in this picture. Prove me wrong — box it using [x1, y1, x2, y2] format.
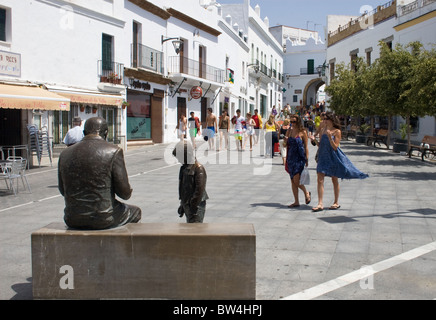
[58, 117, 141, 230]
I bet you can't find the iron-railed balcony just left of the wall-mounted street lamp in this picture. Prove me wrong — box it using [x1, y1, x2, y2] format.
[131, 43, 163, 74]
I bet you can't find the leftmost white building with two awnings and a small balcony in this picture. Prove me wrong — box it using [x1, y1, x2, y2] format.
[0, 0, 129, 165]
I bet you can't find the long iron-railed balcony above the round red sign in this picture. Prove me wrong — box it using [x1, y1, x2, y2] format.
[168, 56, 226, 83]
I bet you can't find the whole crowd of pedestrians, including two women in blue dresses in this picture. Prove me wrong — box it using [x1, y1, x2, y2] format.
[177, 108, 368, 212]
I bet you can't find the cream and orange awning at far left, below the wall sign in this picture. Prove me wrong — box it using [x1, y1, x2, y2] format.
[0, 84, 70, 111]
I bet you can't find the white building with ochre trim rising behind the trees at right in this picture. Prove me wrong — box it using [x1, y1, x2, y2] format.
[327, 0, 436, 141]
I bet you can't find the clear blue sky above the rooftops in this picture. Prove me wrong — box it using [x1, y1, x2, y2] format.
[217, 0, 389, 32]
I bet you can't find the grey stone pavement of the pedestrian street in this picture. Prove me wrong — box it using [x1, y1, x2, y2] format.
[0, 141, 436, 300]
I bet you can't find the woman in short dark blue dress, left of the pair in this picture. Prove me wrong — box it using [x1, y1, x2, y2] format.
[285, 115, 311, 208]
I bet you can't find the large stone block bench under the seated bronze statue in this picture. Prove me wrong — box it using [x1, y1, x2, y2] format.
[31, 223, 256, 300]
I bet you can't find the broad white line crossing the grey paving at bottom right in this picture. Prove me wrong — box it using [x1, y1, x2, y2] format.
[281, 241, 436, 300]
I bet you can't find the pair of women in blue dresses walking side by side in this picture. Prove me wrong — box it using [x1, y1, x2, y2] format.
[283, 112, 368, 212]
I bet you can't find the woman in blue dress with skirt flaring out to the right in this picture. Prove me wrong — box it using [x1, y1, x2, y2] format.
[311, 113, 368, 212]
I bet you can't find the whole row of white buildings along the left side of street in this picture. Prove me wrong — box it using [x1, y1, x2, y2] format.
[0, 0, 283, 158]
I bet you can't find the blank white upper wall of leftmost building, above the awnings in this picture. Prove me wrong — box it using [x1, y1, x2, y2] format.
[0, 0, 129, 90]
